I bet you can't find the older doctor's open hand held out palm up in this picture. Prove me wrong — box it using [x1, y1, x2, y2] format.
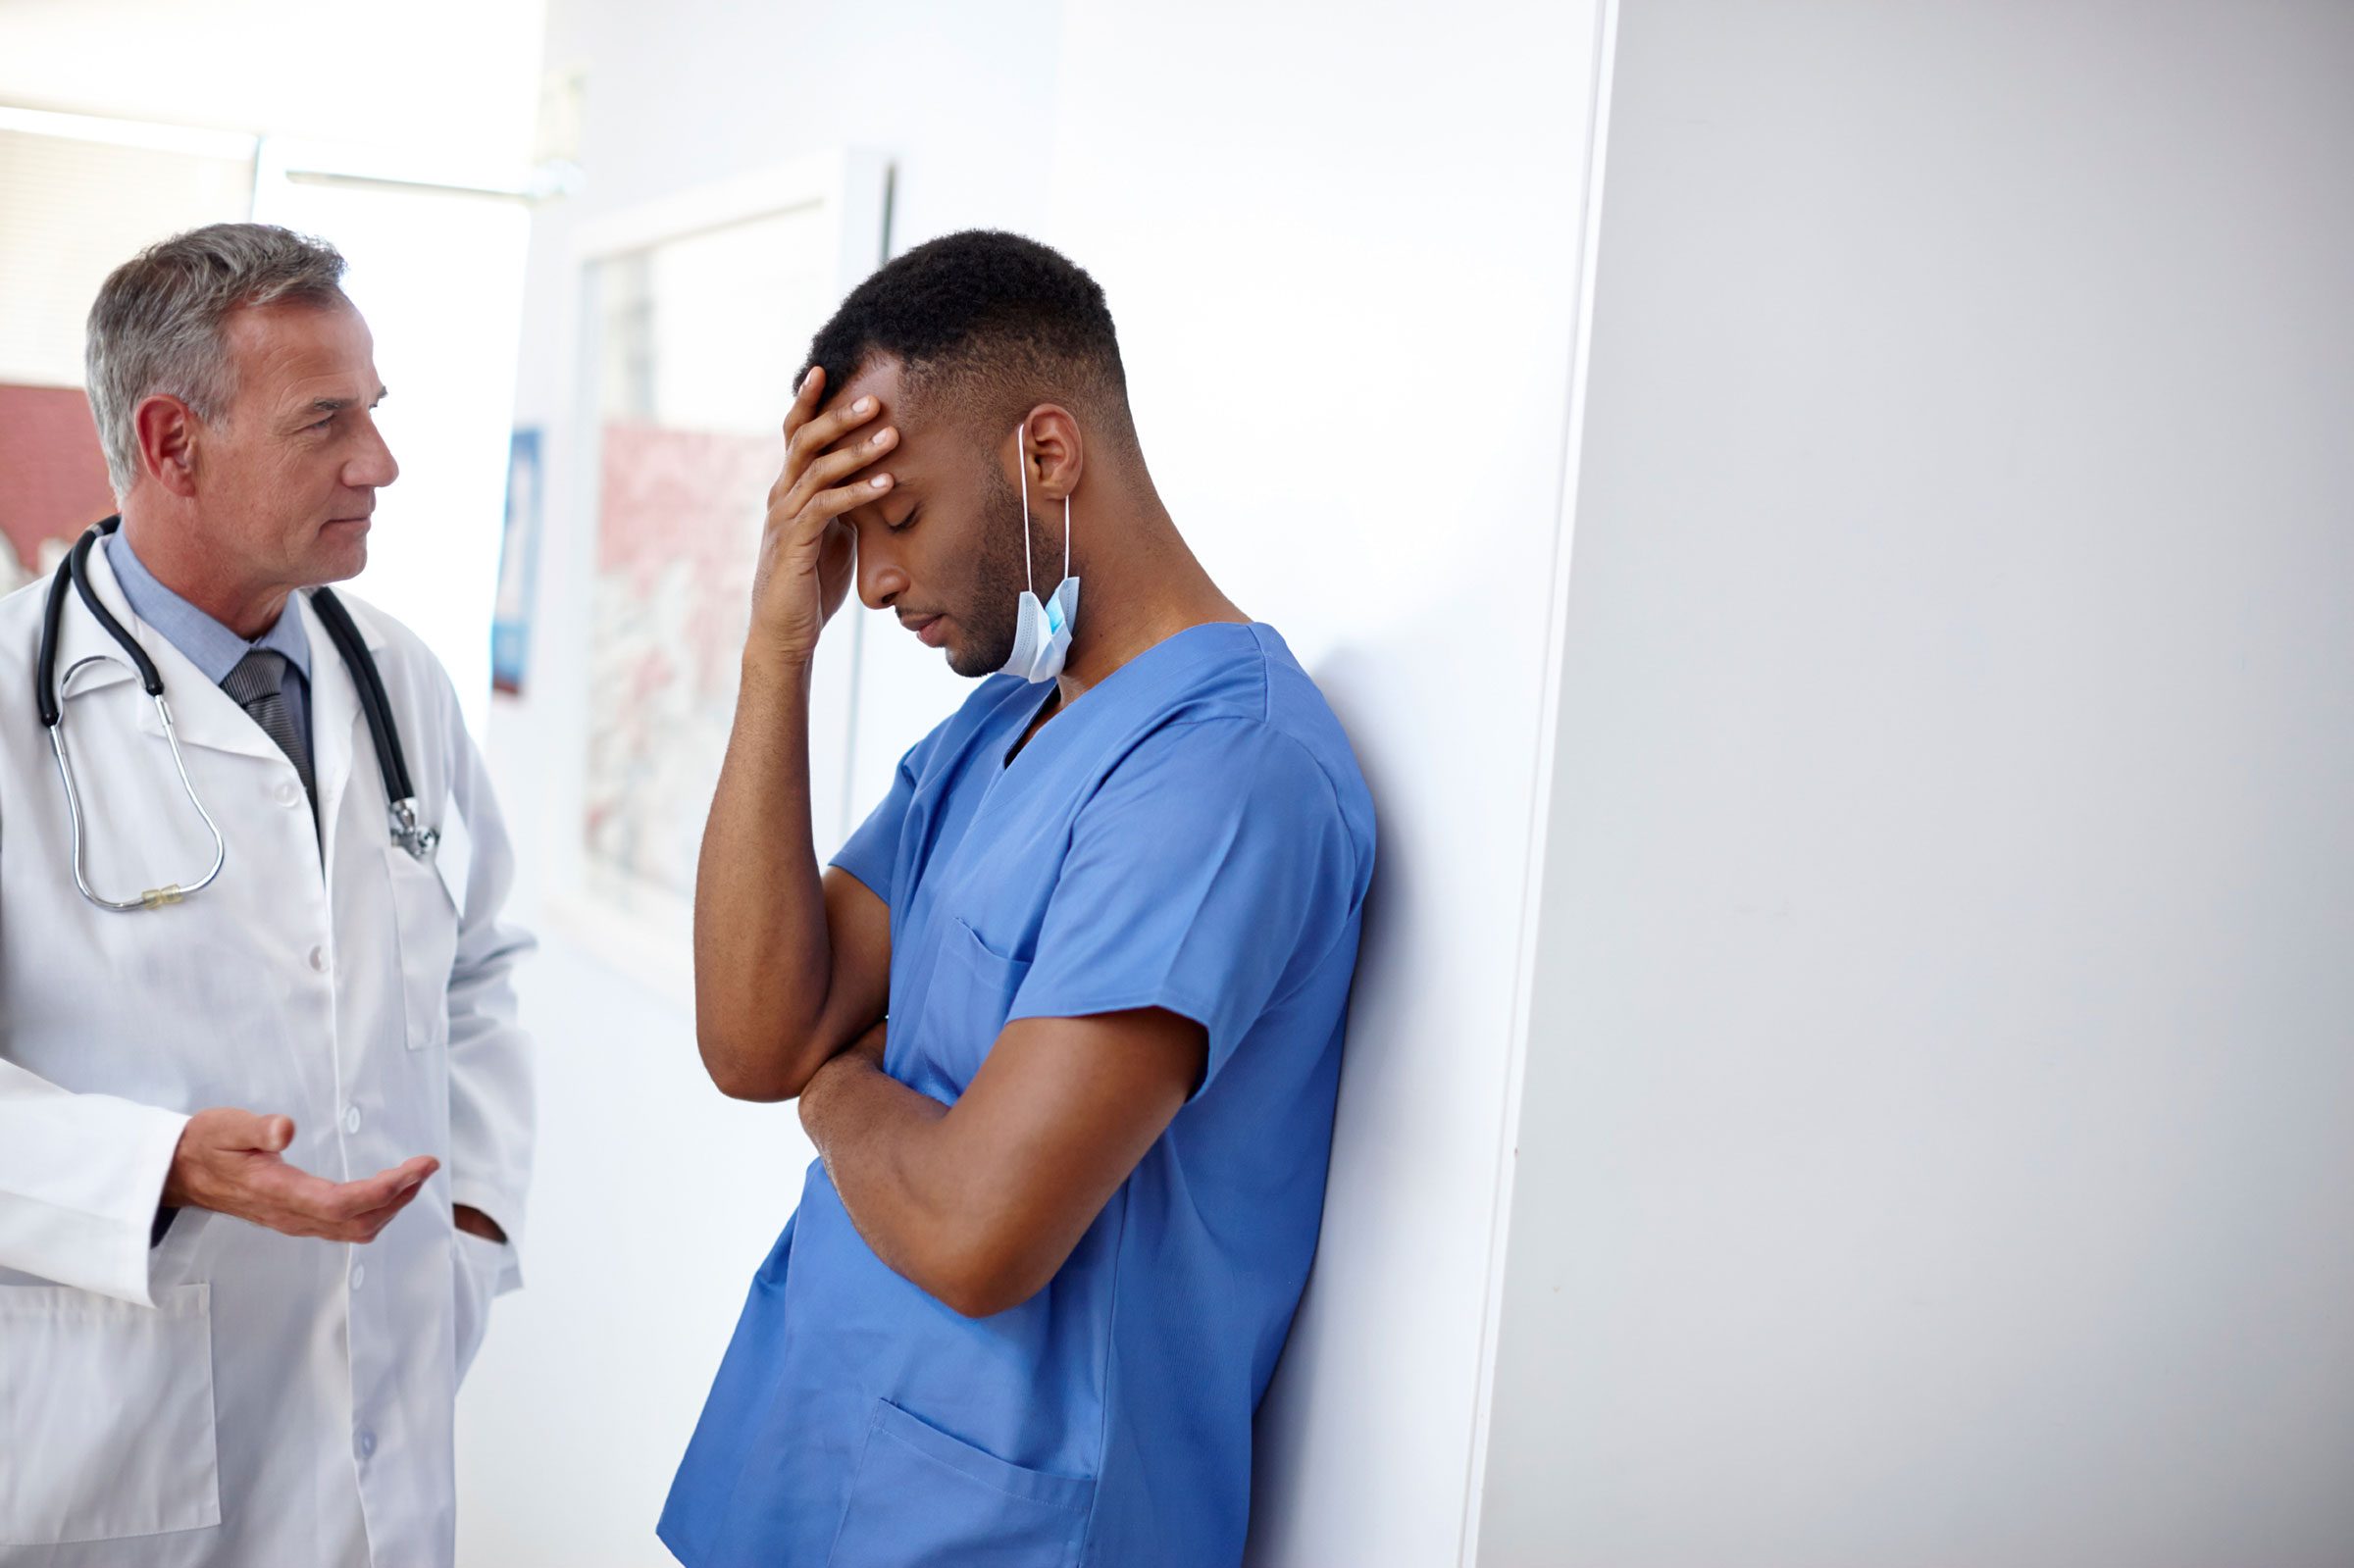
[163, 1106, 440, 1240]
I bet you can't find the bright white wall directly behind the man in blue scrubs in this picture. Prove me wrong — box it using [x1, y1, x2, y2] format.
[485, 0, 1596, 1568]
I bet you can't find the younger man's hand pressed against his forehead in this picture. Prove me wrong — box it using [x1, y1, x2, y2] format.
[751, 368, 899, 664]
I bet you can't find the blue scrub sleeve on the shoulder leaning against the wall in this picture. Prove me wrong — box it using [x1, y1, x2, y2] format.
[1010, 718, 1363, 1086]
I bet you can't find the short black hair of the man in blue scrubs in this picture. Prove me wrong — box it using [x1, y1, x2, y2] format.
[802, 228, 1135, 445]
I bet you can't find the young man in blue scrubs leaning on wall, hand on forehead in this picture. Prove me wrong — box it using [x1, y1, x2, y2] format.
[661, 233, 1375, 1568]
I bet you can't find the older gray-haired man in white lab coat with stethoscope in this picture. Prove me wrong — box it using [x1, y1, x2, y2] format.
[0, 224, 532, 1568]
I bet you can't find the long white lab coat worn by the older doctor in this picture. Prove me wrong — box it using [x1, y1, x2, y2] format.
[0, 551, 532, 1568]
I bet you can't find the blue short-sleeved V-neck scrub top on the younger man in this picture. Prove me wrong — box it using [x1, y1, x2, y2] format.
[659, 622, 1375, 1568]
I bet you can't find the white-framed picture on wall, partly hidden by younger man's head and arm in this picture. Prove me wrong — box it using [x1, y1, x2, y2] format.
[563, 153, 888, 998]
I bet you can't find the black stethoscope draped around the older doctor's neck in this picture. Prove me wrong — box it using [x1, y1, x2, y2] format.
[33, 518, 440, 914]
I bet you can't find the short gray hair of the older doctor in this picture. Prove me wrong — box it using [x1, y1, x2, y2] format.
[84, 224, 351, 497]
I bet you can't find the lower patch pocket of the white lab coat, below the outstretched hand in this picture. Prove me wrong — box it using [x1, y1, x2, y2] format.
[0, 1283, 222, 1546]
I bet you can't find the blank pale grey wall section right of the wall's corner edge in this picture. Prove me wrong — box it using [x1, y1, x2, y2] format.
[1478, 0, 2354, 1568]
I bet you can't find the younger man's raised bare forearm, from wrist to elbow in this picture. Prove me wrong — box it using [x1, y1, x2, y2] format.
[694, 659, 834, 1099]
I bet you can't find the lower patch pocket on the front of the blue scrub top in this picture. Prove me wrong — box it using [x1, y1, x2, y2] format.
[826, 1398, 1095, 1568]
